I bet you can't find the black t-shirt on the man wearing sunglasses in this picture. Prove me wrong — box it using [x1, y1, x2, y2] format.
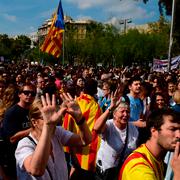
[2, 104, 30, 139]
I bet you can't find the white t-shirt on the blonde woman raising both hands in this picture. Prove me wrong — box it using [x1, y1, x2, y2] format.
[15, 127, 73, 180]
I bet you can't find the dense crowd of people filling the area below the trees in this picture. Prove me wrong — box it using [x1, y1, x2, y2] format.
[0, 62, 180, 180]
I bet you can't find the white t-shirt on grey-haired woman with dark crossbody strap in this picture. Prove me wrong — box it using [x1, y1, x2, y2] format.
[96, 119, 138, 171]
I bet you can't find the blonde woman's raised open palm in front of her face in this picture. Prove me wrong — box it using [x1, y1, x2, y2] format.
[40, 94, 66, 125]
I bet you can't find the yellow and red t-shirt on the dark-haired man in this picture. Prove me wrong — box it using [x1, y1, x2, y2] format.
[118, 144, 164, 180]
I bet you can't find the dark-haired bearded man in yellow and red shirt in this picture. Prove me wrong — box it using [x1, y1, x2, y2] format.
[119, 109, 180, 180]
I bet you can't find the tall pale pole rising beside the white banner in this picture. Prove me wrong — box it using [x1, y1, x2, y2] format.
[168, 0, 176, 72]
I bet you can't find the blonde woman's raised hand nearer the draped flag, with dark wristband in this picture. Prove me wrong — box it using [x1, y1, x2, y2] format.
[60, 93, 82, 122]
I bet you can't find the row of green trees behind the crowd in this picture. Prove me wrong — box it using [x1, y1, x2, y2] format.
[0, 16, 180, 66]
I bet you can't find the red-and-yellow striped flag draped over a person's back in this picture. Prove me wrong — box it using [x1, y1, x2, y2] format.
[63, 94, 102, 171]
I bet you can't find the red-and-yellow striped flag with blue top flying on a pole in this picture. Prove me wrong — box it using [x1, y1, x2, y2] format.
[40, 0, 64, 58]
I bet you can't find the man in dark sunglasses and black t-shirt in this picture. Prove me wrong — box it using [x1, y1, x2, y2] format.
[2, 84, 36, 179]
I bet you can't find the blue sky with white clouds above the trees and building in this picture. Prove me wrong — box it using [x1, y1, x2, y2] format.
[0, 0, 163, 35]
